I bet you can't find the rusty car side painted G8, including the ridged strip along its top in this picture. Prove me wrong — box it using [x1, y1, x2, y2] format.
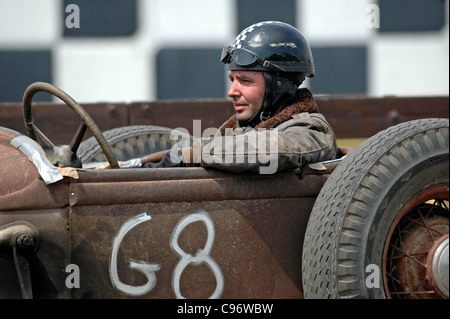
[64, 168, 328, 298]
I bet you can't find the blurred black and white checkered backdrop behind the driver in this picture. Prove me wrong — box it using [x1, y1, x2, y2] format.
[0, 0, 449, 102]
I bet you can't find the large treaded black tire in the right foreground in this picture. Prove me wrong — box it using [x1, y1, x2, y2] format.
[302, 119, 449, 299]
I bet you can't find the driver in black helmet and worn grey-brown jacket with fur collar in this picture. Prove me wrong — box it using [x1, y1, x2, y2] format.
[143, 21, 337, 173]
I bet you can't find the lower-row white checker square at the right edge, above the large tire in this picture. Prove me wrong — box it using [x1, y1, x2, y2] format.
[369, 34, 449, 96]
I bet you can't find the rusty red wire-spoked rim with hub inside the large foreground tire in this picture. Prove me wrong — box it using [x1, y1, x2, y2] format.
[383, 184, 449, 299]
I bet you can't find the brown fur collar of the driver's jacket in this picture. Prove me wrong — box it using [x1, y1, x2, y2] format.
[219, 88, 319, 136]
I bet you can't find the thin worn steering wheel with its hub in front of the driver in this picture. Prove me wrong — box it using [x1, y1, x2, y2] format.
[23, 82, 120, 168]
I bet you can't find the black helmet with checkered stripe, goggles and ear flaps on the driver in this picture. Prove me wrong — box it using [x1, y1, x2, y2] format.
[221, 21, 315, 126]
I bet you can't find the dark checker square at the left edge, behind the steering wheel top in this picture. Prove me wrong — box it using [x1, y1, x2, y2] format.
[0, 50, 52, 103]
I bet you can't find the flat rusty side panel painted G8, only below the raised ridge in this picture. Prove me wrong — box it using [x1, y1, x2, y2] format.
[70, 199, 314, 298]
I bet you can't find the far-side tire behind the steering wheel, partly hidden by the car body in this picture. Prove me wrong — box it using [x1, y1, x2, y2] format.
[78, 125, 191, 163]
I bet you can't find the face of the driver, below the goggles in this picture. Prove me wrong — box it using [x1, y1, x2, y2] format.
[228, 71, 265, 121]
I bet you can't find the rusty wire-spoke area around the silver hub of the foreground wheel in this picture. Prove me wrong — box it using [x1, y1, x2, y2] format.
[385, 199, 448, 299]
